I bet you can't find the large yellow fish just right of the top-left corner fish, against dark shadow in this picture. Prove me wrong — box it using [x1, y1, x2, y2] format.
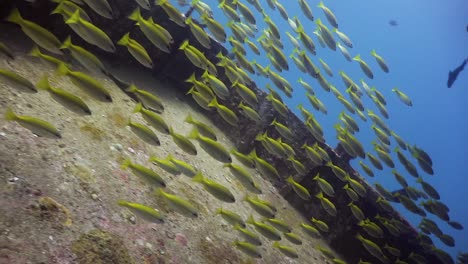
[65, 9, 115, 52]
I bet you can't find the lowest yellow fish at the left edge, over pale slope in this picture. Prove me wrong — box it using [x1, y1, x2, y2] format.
[5, 108, 62, 138]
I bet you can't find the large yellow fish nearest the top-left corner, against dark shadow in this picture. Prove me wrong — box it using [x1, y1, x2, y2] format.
[6, 8, 63, 55]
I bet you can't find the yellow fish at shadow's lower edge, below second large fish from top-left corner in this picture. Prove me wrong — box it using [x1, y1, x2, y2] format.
[57, 36, 106, 72]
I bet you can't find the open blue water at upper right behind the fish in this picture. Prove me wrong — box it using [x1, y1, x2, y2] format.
[183, 0, 468, 258]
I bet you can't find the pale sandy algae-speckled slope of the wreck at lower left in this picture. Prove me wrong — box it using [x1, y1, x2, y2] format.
[0, 28, 338, 264]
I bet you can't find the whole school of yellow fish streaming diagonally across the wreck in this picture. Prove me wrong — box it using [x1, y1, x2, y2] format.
[0, 0, 467, 264]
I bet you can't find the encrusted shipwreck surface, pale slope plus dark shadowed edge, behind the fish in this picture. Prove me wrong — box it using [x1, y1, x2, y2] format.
[0, 0, 439, 264]
